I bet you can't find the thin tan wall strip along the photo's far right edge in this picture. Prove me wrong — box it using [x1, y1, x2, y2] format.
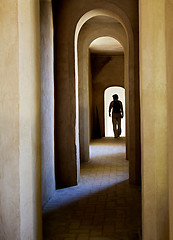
[165, 0, 173, 240]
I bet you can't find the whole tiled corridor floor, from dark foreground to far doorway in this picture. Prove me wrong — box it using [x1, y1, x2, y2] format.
[43, 138, 141, 240]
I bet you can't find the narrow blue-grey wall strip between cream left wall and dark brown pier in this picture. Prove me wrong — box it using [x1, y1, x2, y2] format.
[40, 1, 55, 206]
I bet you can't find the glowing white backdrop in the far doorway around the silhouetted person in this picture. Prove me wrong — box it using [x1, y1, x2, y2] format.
[104, 87, 126, 137]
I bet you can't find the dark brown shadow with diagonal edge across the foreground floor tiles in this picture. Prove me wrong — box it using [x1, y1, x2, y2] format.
[43, 180, 141, 240]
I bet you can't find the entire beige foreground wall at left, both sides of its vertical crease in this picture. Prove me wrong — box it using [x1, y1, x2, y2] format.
[0, 0, 41, 240]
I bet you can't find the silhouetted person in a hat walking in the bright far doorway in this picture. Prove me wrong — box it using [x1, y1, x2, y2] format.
[109, 94, 124, 138]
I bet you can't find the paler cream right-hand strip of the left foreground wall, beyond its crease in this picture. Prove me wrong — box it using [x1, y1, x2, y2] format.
[18, 0, 42, 239]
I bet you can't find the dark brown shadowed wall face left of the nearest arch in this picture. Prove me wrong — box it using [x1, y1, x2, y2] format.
[54, 1, 78, 188]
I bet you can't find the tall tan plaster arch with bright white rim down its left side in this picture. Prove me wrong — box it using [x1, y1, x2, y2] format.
[75, 10, 141, 184]
